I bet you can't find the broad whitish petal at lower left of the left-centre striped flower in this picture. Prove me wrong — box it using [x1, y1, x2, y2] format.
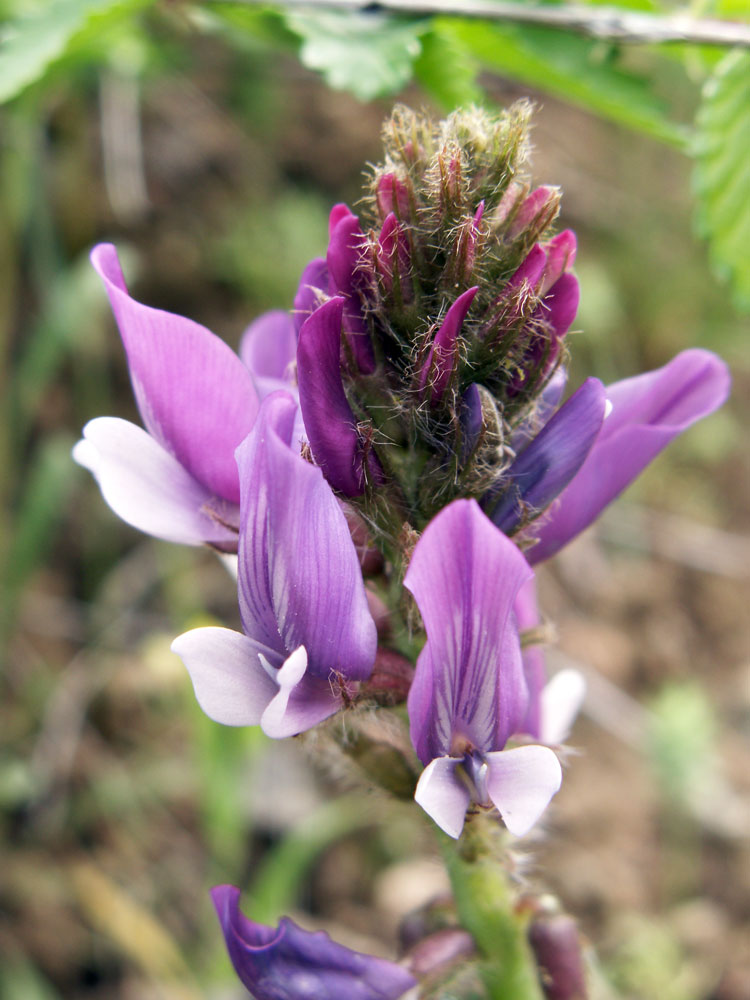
[172, 627, 278, 726]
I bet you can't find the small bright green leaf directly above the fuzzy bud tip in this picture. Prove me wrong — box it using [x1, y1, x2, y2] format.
[414, 27, 482, 111]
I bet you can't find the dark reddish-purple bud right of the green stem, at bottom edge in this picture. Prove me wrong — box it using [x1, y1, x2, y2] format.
[529, 913, 588, 1000]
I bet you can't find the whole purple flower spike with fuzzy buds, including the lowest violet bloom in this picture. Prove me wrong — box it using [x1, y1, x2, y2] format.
[74, 104, 729, 1000]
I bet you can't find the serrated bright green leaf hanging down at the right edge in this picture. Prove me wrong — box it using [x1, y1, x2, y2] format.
[693, 50, 750, 311]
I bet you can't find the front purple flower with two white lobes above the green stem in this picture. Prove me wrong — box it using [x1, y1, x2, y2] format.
[404, 500, 561, 837]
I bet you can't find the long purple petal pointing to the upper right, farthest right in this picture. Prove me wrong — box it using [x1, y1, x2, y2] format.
[529, 348, 730, 562]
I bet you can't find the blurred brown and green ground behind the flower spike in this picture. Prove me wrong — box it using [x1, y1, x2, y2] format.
[0, 5, 750, 1000]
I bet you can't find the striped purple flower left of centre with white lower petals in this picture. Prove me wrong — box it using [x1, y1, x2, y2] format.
[172, 392, 377, 738]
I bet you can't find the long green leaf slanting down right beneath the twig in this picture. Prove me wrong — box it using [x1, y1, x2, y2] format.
[438, 19, 687, 147]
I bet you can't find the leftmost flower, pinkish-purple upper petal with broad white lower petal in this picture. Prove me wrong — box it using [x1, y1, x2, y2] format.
[73, 243, 258, 550]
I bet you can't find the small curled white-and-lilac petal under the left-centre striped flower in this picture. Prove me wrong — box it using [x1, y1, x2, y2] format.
[260, 646, 343, 740]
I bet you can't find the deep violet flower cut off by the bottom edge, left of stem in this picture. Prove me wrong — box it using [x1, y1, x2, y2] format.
[211, 885, 416, 1000]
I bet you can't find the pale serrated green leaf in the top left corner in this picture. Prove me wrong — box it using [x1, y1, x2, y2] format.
[0, 0, 120, 101]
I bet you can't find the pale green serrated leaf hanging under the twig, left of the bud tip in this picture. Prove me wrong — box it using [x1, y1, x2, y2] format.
[286, 11, 429, 101]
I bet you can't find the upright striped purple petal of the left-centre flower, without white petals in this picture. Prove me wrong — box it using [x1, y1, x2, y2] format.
[237, 393, 377, 682]
